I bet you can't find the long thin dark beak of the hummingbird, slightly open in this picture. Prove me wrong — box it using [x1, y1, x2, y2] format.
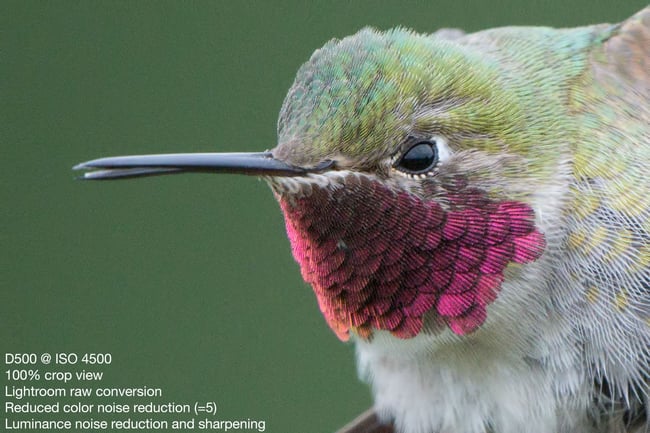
[73, 152, 334, 180]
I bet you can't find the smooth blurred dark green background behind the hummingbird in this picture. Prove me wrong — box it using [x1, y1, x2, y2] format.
[0, 0, 646, 433]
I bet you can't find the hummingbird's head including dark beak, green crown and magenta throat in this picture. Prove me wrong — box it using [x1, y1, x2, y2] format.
[77, 29, 561, 340]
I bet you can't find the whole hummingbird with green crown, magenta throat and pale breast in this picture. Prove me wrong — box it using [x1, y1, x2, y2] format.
[75, 7, 650, 433]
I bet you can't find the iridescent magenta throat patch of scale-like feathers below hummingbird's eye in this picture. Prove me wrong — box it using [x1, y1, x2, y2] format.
[279, 176, 545, 340]
